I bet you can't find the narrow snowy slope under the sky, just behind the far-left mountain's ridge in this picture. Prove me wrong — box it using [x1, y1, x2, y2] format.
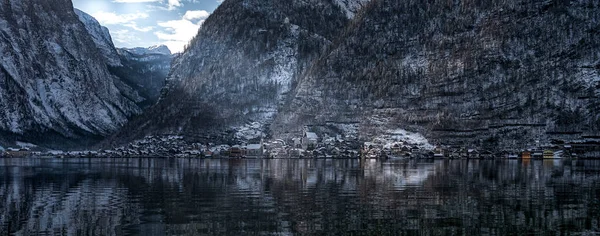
[75, 9, 121, 66]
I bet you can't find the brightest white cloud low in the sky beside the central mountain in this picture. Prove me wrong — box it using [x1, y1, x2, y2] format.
[154, 11, 210, 52]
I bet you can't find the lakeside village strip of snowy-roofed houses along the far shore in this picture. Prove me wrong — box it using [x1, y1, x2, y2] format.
[0, 130, 600, 160]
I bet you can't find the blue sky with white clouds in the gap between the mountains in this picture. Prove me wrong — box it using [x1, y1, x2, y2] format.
[73, 0, 222, 52]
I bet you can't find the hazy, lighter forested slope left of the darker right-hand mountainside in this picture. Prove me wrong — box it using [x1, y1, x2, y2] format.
[112, 0, 356, 143]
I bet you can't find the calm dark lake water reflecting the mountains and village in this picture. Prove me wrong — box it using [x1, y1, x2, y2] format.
[0, 159, 600, 235]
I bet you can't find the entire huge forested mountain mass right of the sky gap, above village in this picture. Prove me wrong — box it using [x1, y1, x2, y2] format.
[119, 0, 600, 149]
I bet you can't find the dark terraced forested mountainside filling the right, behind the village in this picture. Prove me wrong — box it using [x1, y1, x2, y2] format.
[273, 0, 600, 147]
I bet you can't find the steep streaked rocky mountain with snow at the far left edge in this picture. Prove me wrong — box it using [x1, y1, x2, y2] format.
[0, 0, 141, 146]
